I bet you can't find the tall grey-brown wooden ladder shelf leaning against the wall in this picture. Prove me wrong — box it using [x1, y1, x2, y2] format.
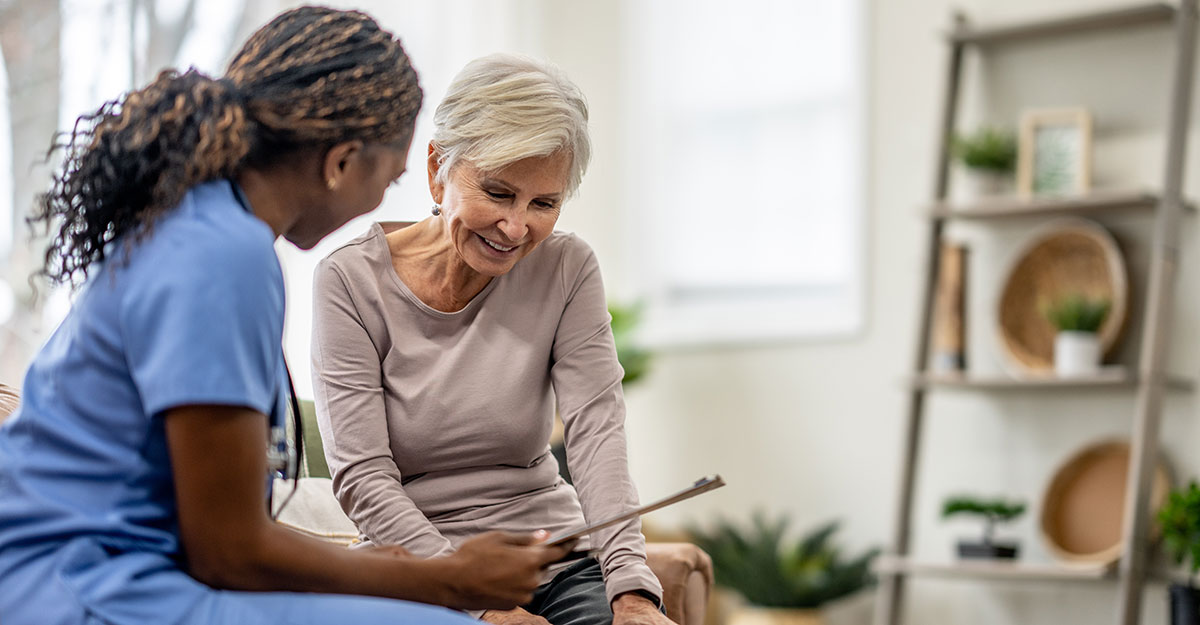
[875, 0, 1198, 625]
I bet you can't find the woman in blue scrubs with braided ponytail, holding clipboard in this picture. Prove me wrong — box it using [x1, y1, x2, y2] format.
[0, 7, 564, 625]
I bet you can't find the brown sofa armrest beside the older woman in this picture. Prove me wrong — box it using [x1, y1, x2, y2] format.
[646, 542, 713, 625]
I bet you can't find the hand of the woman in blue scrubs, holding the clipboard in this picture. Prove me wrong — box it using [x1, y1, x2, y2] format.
[439, 531, 571, 609]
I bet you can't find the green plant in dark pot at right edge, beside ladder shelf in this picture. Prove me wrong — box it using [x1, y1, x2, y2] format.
[1158, 480, 1200, 625]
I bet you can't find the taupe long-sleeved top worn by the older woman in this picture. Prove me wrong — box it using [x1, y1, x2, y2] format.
[312, 224, 662, 602]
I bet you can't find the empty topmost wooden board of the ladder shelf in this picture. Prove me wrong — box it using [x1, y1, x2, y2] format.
[948, 2, 1178, 46]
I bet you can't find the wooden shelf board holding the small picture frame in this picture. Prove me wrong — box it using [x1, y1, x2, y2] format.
[929, 191, 1194, 220]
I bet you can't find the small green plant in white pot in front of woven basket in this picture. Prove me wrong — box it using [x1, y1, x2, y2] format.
[1043, 293, 1112, 378]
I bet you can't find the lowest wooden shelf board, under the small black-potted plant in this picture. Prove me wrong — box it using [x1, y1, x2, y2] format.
[875, 555, 1117, 582]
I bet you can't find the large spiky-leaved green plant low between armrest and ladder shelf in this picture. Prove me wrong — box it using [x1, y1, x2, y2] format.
[689, 513, 878, 625]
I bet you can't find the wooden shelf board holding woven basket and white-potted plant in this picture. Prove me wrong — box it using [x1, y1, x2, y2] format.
[912, 366, 1194, 391]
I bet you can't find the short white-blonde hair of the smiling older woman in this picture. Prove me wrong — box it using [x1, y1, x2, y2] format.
[433, 54, 592, 197]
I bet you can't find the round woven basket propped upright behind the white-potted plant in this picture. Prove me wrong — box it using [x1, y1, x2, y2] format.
[996, 218, 1129, 373]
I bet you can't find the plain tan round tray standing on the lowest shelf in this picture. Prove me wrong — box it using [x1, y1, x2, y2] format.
[1040, 440, 1170, 565]
